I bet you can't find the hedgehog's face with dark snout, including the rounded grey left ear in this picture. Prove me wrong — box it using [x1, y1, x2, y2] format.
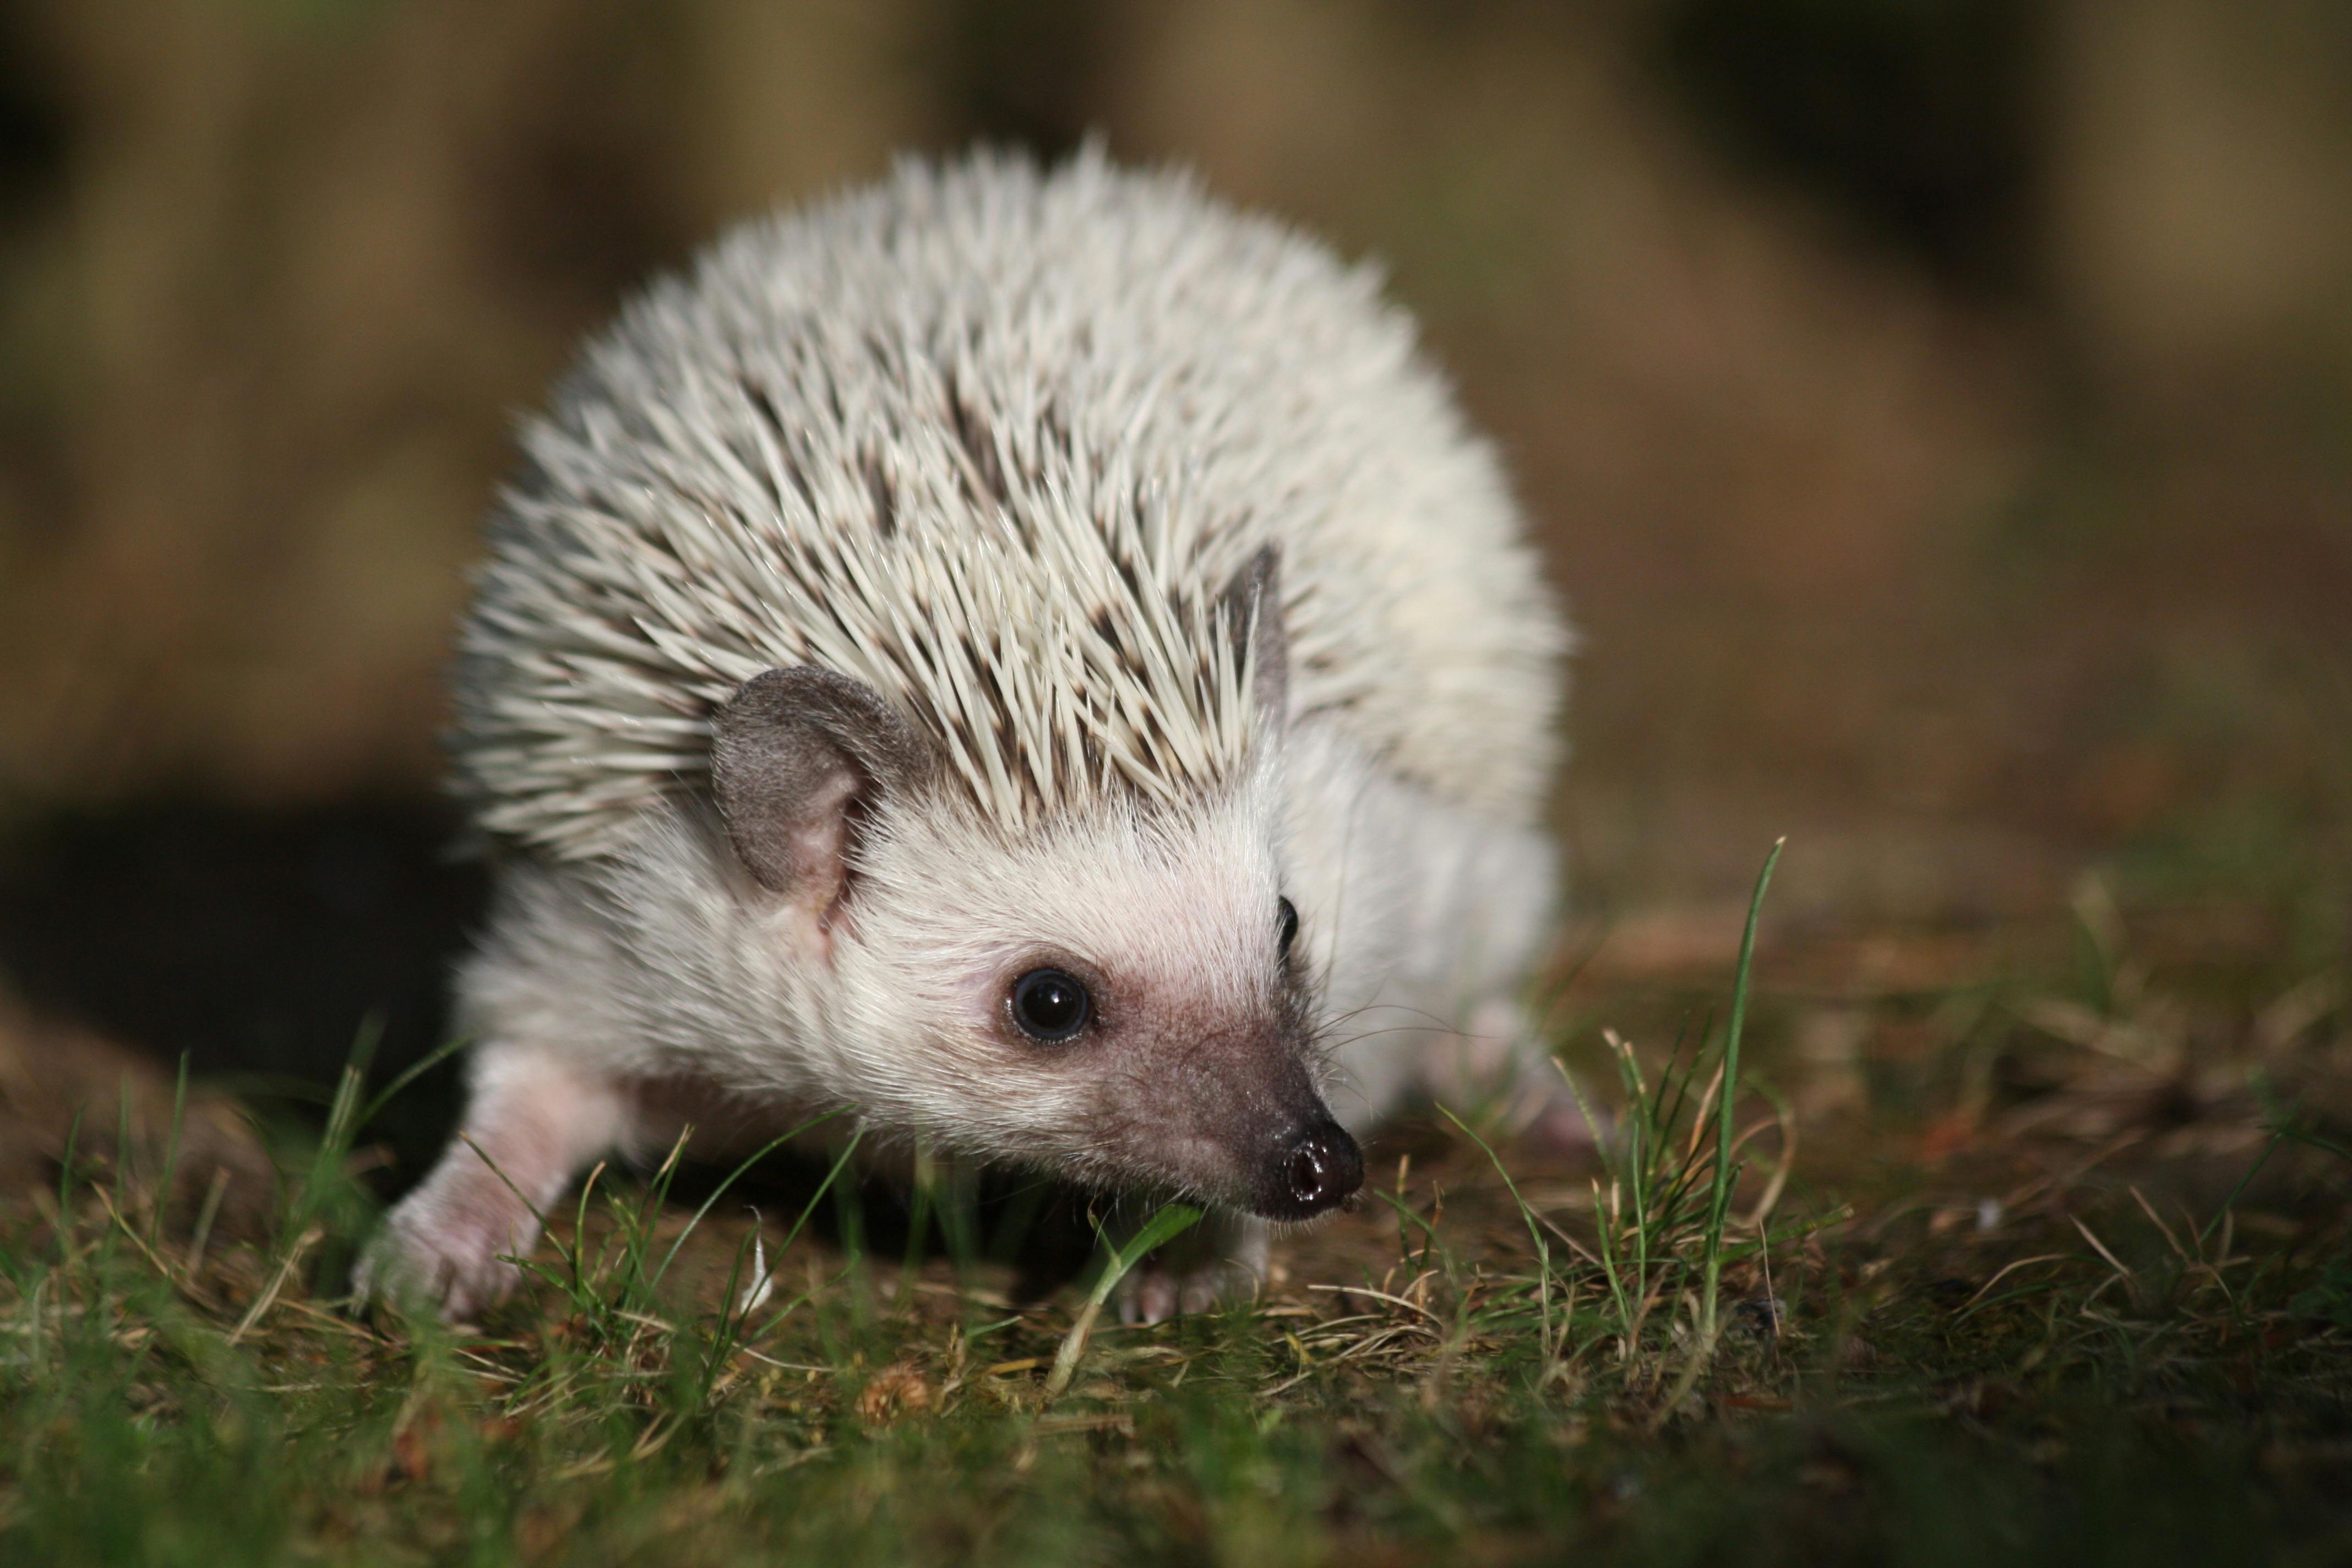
[712, 670, 1362, 1220]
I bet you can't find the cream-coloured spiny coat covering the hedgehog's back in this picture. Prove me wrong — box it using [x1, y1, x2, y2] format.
[451, 153, 1566, 858]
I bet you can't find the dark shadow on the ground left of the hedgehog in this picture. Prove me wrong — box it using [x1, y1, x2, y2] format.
[0, 799, 487, 1166]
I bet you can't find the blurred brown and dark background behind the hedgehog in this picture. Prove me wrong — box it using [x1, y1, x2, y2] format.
[0, 0, 2352, 1166]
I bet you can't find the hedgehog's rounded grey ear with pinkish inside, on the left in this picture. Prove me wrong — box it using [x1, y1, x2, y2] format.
[710, 665, 932, 929]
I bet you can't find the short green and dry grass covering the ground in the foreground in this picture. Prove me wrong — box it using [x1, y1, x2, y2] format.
[0, 865, 2352, 1566]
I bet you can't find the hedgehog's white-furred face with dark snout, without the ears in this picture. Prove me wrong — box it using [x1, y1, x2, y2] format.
[830, 769, 1362, 1220]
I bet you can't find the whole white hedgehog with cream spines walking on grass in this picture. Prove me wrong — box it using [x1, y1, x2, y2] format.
[362, 153, 1569, 1316]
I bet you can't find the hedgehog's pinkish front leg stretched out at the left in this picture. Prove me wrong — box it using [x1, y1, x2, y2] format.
[353, 1046, 630, 1319]
